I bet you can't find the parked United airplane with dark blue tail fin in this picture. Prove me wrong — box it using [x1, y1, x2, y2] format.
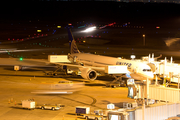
[51, 29, 154, 80]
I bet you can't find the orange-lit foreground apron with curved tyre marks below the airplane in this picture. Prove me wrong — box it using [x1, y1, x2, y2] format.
[0, 67, 134, 120]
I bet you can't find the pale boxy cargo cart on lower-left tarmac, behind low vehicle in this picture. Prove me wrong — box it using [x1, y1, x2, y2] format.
[22, 100, 35, 109]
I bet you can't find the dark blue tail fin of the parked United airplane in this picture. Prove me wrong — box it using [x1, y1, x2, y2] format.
[67, 28, 80, 54]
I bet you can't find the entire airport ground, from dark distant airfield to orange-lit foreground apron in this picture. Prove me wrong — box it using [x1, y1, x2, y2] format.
[0, 19, 180, 120]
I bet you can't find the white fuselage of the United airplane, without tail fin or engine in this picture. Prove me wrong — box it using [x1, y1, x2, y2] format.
[69, 53, 153, 80]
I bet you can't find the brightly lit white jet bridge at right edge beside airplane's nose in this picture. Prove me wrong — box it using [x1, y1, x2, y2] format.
[142, 55, 180, 86]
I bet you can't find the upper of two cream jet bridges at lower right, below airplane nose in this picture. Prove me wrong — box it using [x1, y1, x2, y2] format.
[127, 80, 180, 103]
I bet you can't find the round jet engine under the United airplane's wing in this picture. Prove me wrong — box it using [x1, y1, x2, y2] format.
[80, 68, 97, 80]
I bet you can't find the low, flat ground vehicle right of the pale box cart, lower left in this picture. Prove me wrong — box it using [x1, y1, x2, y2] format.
[36, 104, 64, 110]
